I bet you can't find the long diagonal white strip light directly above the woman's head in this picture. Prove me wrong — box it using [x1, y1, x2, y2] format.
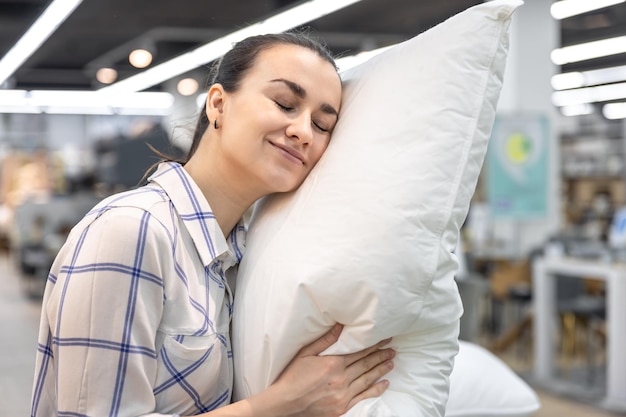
[101, 0, 361, 92]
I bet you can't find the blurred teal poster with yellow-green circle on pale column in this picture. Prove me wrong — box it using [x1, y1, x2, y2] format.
[487, 115, 549, 219]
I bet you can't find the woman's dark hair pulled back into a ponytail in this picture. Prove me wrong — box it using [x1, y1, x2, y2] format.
[184, 30, 337, 162]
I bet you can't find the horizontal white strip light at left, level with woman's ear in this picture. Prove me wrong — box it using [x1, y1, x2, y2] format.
[0, 90, 174, 116]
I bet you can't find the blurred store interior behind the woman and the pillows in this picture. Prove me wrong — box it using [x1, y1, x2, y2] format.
[0, 0, 626, 417]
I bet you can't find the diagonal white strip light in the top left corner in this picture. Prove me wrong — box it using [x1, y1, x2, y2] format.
[0, 0, 83, 85]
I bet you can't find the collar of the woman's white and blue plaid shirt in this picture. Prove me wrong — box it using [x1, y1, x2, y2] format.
[148, 162, 246, 269]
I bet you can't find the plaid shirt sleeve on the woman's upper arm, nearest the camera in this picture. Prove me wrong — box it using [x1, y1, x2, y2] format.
[44, 208, 171, 416]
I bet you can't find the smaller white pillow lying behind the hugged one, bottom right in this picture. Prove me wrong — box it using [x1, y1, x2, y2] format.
[446, 341, 541, 417]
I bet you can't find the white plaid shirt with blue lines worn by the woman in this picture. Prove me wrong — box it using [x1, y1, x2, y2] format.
[31, 163, 245, 417]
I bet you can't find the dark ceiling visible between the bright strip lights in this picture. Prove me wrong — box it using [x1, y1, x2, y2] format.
[0, 0, 626, 89]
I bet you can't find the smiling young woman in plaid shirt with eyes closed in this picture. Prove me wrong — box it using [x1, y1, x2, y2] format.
[31, 33, 394, 417]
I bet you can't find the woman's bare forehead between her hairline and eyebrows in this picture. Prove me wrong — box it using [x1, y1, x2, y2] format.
[244, 44, 341, 106]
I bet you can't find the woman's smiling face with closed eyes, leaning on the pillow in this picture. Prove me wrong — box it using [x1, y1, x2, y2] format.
[209, 45, 341, 195]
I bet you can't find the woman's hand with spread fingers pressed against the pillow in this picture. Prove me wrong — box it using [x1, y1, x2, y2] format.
[269, 324, 395, 417]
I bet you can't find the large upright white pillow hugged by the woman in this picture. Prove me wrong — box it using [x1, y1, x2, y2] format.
[232, 0, 521, 417]
